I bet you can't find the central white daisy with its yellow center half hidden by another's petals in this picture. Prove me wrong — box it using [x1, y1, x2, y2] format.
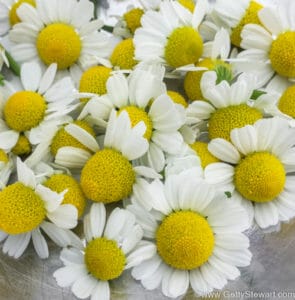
[80, 68, 185, 172]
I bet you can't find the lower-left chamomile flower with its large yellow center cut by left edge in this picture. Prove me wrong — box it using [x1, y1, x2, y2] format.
[0, 158, 80, 258]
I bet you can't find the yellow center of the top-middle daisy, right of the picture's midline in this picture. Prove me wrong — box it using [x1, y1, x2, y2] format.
[165, 27, 203, 68]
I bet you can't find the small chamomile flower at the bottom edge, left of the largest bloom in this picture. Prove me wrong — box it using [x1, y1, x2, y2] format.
[53, 203, 143, 300]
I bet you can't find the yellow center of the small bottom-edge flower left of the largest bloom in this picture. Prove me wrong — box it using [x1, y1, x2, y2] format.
[84, 238, 126, 281]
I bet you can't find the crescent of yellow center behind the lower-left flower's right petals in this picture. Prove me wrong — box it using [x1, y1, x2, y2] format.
[43, 174, 86, 217]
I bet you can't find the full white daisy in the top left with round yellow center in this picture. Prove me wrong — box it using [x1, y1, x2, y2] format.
[9, 0, 113, 79]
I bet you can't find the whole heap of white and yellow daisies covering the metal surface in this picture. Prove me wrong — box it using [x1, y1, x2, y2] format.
[0, 0, 295, 300]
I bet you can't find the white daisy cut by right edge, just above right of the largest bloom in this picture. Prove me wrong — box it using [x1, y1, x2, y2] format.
[205, 117, 295, 228]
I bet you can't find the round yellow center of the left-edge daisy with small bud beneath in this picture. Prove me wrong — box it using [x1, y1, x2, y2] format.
[4, 91, 46, 132]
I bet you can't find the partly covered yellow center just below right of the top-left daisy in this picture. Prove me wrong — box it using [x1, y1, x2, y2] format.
[79, 66, 112, 102]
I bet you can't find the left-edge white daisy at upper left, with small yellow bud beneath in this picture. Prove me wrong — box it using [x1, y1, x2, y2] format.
[0, 62, 78, 155]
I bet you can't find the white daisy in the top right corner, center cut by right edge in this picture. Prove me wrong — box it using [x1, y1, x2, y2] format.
[238, 1, 295, 84]
